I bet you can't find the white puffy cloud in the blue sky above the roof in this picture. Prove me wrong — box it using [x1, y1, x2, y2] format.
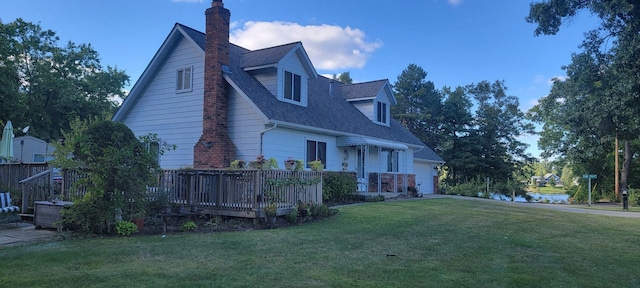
[230, 21, 382, 70]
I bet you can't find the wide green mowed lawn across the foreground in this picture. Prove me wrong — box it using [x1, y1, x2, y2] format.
[0, 198, 640, 287]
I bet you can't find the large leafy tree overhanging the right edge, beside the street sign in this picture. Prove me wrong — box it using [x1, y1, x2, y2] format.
[526, 0, 640, 193]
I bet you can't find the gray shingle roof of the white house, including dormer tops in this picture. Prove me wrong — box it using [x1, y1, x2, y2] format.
[182, 26, 443, 162]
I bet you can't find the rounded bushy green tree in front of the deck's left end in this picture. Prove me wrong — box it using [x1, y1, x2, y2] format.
[54, 120, 158, 234]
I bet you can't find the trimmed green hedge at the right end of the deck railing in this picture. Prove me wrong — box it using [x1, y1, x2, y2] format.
[322, 172, 358, 203]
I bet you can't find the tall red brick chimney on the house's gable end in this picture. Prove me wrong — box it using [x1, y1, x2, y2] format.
[193, 0, 236, 169]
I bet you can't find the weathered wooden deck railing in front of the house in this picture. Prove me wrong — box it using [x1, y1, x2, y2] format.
[62, 169, 322, 218]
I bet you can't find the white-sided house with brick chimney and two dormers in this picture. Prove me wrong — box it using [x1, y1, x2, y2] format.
[113, 0, 443, 193]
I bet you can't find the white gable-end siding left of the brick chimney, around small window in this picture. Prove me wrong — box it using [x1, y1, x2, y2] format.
[122, 39, 204, 169]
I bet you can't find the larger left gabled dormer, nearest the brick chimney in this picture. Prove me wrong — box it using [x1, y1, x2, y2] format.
[241, 42, 318, 107]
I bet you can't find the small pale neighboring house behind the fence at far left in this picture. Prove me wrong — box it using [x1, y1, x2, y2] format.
[13, 135, 56, 163]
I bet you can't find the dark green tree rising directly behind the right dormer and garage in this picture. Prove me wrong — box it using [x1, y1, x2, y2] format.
[391, 64, 442, 153]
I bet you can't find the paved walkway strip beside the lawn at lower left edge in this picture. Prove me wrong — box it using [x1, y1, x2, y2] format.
[0, 223, 56, 248]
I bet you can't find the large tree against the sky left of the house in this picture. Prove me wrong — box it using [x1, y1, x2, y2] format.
[0, 19, 129, 139]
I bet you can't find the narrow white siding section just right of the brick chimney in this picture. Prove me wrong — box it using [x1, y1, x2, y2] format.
[227, 89, 265, 162]
